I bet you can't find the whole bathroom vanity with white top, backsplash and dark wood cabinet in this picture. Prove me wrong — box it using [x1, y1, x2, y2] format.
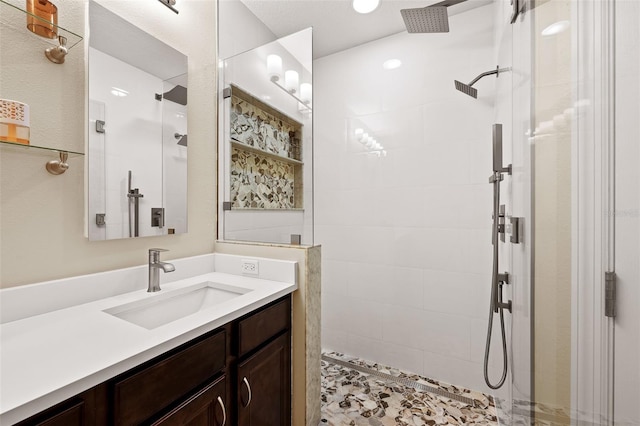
[0, 254, 298, 426]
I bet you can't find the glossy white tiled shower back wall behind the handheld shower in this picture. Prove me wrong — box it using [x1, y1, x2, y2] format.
[314, 5, 501, 396]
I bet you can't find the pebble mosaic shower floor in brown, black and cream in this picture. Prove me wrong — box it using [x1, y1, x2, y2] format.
[320, 352, 498, 426]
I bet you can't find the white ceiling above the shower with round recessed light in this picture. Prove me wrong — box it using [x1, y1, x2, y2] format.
[242, 0, 492, 59]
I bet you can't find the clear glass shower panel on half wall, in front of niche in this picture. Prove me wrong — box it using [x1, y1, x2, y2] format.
[218, 28, 313, 245]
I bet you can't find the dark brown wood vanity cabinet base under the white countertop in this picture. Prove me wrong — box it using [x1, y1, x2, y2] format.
[12, 296, 291, 426]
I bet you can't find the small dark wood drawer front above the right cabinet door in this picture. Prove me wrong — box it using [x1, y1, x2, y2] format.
[238, 296, 291, 356]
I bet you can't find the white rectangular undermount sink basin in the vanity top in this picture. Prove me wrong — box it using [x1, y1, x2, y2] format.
[103, 281, 251, 330]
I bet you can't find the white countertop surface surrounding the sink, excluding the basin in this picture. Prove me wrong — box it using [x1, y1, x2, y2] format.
[0, 272, 297, 425]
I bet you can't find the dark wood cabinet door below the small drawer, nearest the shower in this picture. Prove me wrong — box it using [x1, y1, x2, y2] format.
[237, 332, 291, 426]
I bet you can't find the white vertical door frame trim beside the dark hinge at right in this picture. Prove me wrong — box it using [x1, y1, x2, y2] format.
[571, 0, 615, 425]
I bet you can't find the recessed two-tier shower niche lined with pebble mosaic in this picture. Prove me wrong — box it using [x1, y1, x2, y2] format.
[226, 85, 304, 211]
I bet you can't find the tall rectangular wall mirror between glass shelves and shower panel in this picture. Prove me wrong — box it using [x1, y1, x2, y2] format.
[87, 0, 188, 241]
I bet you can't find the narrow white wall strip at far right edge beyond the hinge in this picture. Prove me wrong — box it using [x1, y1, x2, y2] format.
[614, 0, 640, 425]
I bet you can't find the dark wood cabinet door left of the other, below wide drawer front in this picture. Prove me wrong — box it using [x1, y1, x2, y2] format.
[152, 376, 229, 426]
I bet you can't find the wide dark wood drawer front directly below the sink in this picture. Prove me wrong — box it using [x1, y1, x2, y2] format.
[114, 331, 226, 425]
